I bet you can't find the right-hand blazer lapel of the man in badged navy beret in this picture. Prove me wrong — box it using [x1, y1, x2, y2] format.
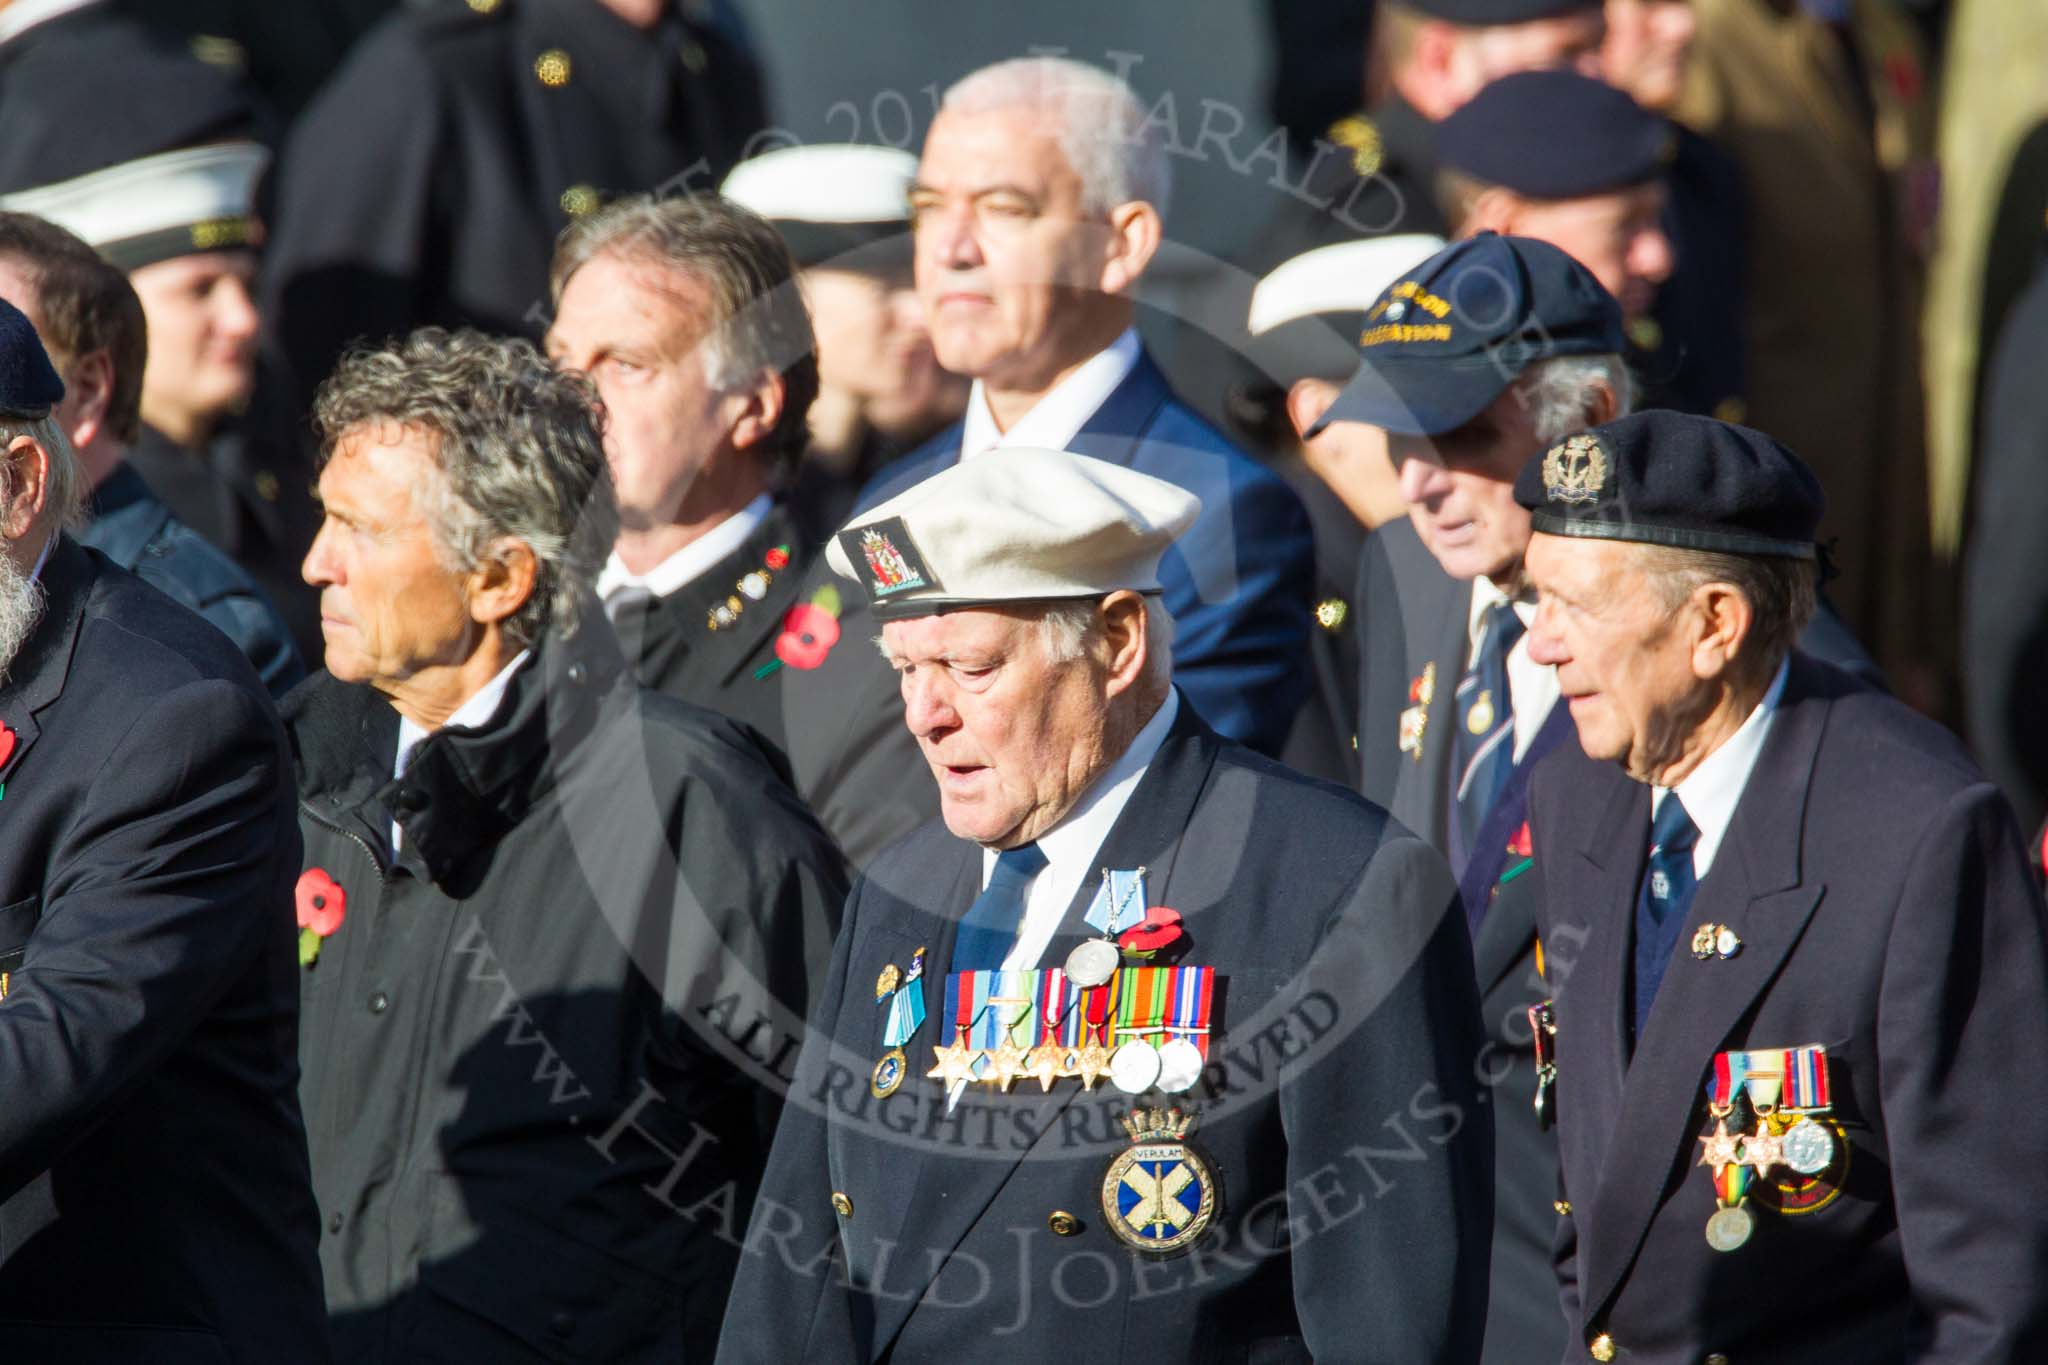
[1581, 671, 1827, 1320]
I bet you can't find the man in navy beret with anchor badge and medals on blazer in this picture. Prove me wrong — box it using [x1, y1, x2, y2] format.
[1516, 411, 2048, 1363]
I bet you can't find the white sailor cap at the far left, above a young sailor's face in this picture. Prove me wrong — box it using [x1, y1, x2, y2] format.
[0, 141, 270, 270]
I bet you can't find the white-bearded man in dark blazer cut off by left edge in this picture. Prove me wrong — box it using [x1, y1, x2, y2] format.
[0, 303, 328, 1365]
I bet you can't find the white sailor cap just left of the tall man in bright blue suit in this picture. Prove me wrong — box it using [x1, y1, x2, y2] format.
[719, 143, 918, 270]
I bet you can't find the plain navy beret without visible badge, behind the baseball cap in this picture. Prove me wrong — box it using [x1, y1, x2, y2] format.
[1436, 72, 1675, 199]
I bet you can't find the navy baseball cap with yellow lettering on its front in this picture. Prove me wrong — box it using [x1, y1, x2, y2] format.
[1309, 231, 1628, 436]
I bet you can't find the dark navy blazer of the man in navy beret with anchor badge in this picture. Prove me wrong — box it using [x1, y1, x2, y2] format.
[1532, 655, 2048, 1363]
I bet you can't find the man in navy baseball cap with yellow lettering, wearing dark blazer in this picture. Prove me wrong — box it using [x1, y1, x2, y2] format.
[1319, 233, 1630, 1363]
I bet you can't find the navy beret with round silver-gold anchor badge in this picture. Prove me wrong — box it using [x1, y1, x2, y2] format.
[1516, 407, 1827, 559]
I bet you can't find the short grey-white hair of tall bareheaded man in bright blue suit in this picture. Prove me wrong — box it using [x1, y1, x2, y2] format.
[940, 57, 1174, 217]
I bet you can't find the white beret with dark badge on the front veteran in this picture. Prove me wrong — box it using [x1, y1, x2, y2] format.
[825, 446, 1202, 620]
